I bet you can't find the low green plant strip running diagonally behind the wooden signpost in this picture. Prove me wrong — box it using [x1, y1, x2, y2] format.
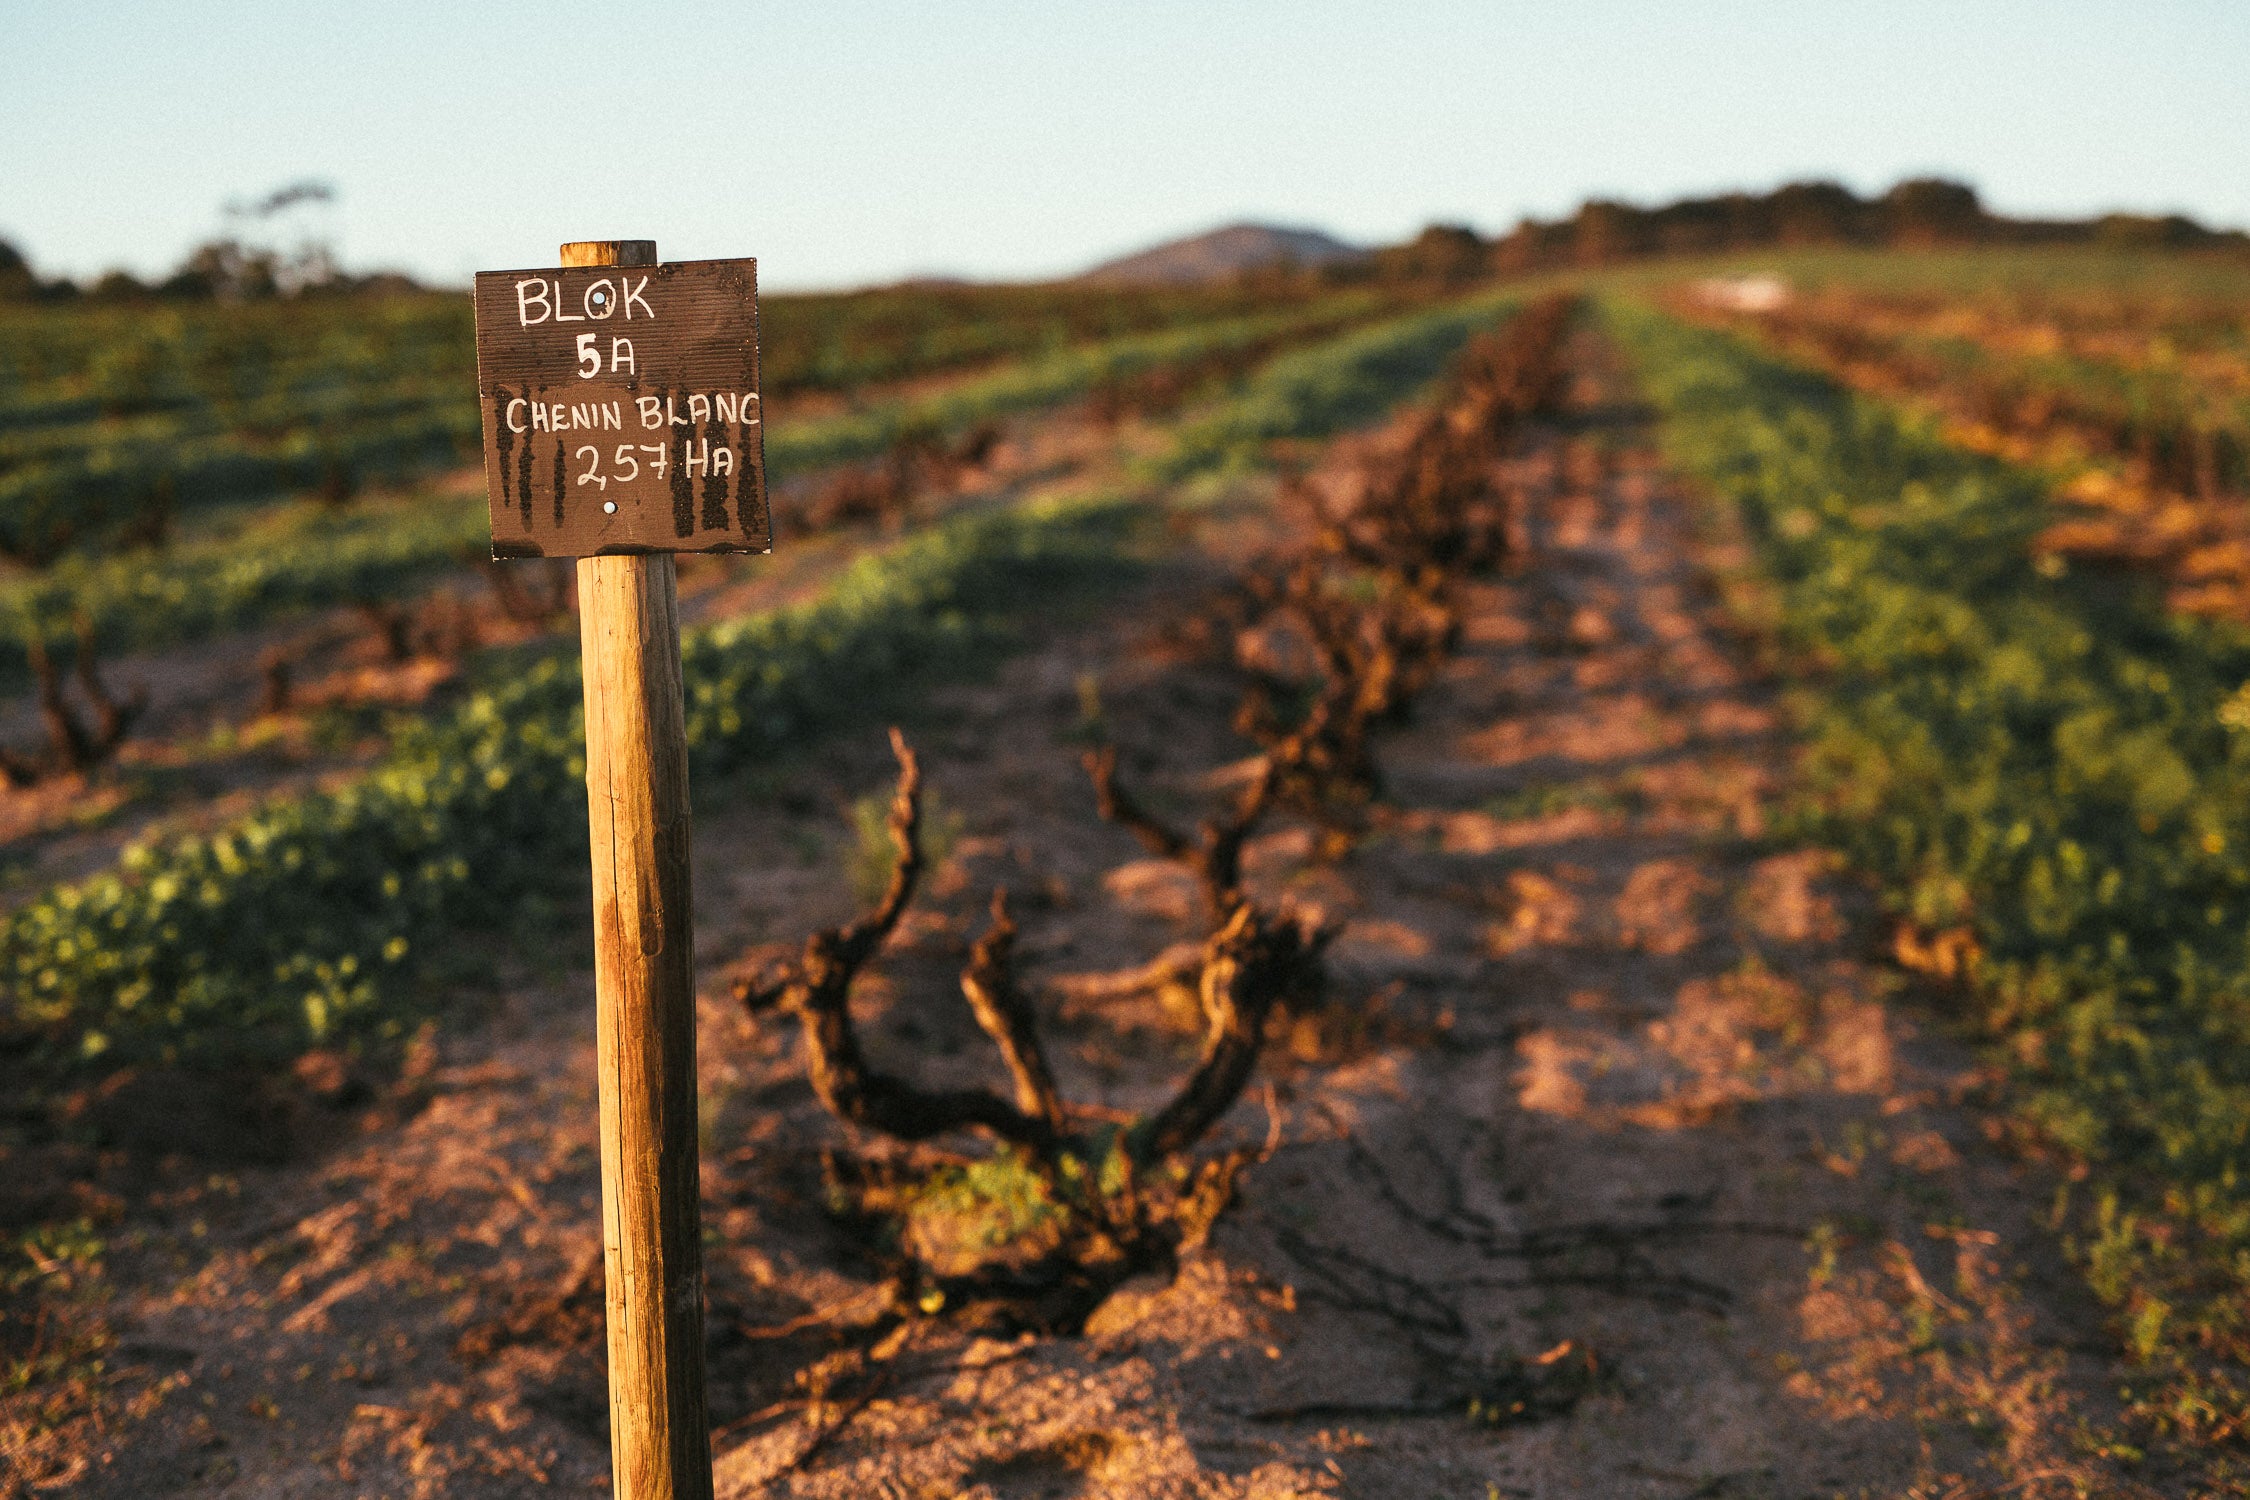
[0, 299, 1505, 1079]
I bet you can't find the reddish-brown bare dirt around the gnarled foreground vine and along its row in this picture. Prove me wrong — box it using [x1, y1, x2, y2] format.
[17, 346, 2140, 1500]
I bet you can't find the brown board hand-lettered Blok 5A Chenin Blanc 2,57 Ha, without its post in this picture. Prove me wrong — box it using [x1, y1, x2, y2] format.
[477, 261, 774, 558]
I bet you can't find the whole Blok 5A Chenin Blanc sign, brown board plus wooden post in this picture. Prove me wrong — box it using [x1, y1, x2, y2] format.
[477, 241, 720, 1500]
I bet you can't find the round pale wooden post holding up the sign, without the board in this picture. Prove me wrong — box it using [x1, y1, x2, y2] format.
[563, 241, 711, 1500]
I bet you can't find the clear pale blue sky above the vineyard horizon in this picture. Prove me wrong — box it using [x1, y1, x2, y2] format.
[0, 0, 2250, 288]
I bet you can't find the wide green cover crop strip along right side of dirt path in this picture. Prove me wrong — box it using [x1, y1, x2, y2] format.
[1607, 304, 2250, 1437]
